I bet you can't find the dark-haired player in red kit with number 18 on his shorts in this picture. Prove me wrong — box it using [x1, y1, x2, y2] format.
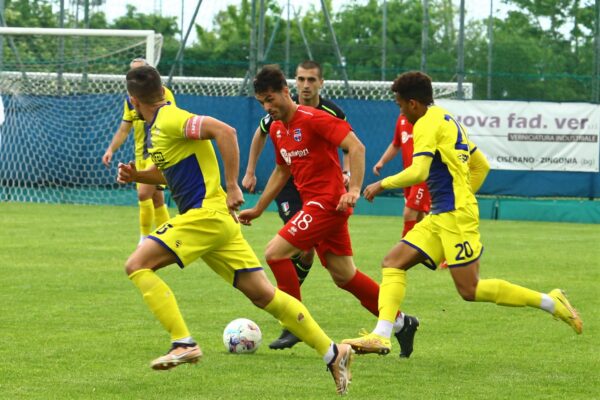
[239, 66, 418, 357]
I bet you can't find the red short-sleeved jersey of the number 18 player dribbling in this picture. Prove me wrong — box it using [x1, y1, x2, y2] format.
[269, 105, 352, 209]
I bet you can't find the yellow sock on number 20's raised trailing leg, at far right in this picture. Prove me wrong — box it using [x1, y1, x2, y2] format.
[475, 279, 542, 308]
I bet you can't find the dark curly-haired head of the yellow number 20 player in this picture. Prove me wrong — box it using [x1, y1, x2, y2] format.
[392, 71, 433, 124]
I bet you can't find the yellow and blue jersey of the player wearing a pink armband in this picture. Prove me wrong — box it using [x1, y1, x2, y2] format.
[146, 103, 228, 214]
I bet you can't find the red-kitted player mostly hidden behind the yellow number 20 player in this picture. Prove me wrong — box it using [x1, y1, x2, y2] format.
[373, 114, 431, 237]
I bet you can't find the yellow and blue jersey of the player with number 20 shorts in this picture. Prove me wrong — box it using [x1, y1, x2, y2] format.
[413, 105, 477, 214]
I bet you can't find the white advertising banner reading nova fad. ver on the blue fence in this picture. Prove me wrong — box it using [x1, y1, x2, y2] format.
[436, 99, 600, 172]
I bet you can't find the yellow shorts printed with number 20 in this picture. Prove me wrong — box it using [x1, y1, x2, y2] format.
[402, 204, 483, 269]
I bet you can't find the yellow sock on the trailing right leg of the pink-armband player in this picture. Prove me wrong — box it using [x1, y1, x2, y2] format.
[265, 289, 332, 356]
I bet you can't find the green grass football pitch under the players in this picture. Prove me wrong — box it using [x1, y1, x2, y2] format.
[0, 203, 600, 400]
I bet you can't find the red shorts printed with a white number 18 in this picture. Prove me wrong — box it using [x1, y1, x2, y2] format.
[279, 201, 352, 267]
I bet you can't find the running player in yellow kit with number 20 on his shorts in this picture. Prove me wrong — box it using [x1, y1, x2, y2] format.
[343, 72, 583, 354]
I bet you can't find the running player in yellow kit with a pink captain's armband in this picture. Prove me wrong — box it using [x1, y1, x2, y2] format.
[117, 66, 352, 394]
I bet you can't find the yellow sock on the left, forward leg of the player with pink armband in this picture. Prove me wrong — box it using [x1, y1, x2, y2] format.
[129, 269, 191, 341]
